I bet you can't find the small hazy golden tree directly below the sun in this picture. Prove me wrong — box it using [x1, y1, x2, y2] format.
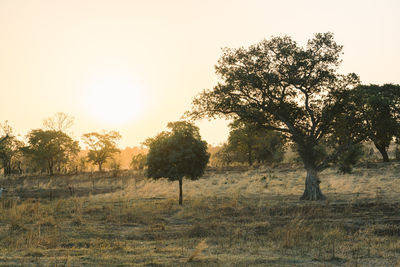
[82, 131, 121, 171]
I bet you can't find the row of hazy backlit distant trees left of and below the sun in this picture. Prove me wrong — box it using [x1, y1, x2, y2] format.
[0, 112, 121, 176]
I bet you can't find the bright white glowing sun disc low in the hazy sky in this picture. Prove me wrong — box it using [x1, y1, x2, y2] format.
[84, 77, 147, 125]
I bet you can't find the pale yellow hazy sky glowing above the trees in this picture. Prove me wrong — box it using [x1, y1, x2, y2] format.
[0, 0, 400, 147]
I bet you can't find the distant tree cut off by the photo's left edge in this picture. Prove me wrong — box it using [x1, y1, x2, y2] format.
[0, 121, 24, 175]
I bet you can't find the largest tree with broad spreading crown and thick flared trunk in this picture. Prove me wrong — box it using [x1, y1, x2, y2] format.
[188, 33, 359, 200]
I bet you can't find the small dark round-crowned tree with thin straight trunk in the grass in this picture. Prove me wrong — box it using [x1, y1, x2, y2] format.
[145, 121, 210, 205]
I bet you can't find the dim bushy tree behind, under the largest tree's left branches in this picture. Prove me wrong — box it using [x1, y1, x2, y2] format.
[228, 120, 284, 166]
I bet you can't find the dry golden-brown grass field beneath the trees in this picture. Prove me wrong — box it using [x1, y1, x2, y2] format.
[0, 163, 400, 266]
